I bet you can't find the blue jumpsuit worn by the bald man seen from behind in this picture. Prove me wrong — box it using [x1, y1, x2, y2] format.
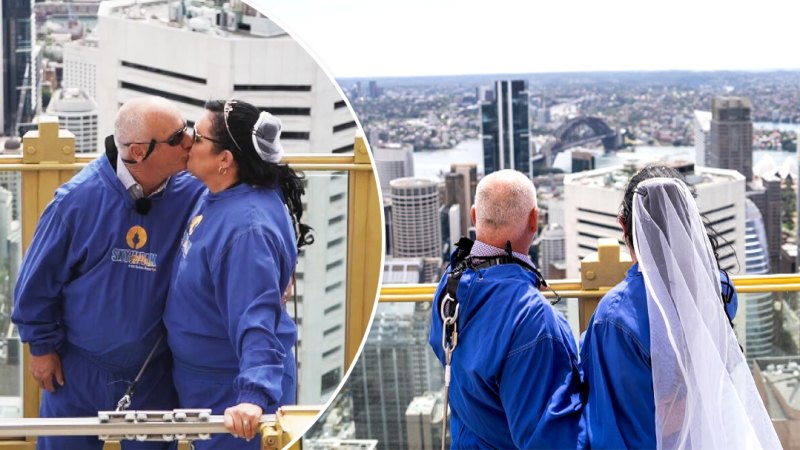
[430, 250, 582, 449]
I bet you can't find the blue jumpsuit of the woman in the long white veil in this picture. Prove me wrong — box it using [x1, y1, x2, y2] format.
[581, 264, 738, 449]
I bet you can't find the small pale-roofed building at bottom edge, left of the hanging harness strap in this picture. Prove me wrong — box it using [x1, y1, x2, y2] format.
[406, 392, 449, 450]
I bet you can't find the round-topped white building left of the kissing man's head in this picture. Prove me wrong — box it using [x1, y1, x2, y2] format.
[47, 88, 98, 153]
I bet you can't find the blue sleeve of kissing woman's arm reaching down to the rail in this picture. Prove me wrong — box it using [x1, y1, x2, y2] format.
[212, 229, 289, 410]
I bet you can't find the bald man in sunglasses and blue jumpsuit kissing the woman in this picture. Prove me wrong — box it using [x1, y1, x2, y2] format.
[12, 97, 202, 449]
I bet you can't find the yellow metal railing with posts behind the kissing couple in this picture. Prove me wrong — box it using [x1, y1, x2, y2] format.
[0, 116, 383, 449]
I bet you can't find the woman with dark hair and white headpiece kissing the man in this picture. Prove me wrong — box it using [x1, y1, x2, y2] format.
[164, 100, 312, 449]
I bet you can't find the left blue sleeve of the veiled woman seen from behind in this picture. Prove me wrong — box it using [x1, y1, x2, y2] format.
[581, 321, 656, 448]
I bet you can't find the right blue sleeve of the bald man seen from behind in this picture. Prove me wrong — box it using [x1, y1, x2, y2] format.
[499, 312, 582, 448]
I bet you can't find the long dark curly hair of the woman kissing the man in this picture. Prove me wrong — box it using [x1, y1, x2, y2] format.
[205, 100, 314, 249]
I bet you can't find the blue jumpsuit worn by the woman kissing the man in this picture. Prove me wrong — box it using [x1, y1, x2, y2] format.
[164, 184, 297, 449]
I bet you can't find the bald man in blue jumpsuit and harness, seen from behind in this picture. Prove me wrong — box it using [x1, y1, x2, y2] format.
[430, 170, 582, 449]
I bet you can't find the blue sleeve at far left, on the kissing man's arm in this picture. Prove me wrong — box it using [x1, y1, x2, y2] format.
[11, 202, 75, 356]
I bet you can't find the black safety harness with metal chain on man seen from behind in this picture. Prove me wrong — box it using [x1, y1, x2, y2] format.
[439, 237, 561, 450]
